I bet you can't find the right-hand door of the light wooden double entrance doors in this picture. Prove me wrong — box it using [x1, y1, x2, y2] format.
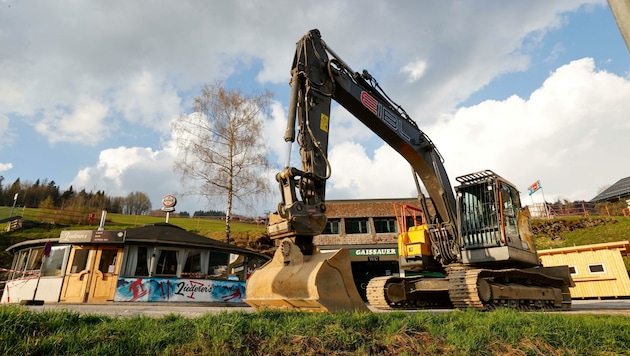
[88, 246, 122, 303]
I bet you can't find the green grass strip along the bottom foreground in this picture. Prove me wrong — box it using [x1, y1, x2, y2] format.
[0, 306, 630, 355]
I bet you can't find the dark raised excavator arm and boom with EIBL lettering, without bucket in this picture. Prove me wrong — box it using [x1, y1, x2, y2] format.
[268, 30, 459, 262]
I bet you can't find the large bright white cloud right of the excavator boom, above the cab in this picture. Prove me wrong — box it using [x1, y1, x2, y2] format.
[427, 58, 630, 203]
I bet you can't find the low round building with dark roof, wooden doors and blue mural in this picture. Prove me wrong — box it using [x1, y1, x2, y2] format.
[0, 224, 269, 304]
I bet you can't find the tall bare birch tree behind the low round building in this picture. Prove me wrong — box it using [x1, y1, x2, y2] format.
[172, 83, 272, 242]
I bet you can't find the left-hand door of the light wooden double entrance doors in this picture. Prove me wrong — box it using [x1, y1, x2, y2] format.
[60, 246, 95, 303]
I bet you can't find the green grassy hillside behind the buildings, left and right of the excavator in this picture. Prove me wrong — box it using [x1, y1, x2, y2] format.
[0, 207, 630, 270]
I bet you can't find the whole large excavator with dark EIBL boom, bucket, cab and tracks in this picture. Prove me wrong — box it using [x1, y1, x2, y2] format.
[245, 30, 574, 312]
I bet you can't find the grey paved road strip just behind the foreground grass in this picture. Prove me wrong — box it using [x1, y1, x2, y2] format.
[17, 299, 630, 318]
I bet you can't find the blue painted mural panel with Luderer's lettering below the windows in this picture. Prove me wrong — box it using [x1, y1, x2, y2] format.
[114, 277, 245, 303]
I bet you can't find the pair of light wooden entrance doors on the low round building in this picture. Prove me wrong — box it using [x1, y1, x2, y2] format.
[61, 246, 122, 303]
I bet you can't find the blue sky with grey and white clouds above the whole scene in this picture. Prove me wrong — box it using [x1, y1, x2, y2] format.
[0, 0, 630, 214]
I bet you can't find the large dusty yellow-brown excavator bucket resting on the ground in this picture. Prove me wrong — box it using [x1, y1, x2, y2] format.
[245, 239, 369, 312]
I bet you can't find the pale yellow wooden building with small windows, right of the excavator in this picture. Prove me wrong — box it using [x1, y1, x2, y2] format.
[538, 241, 630, 299]
